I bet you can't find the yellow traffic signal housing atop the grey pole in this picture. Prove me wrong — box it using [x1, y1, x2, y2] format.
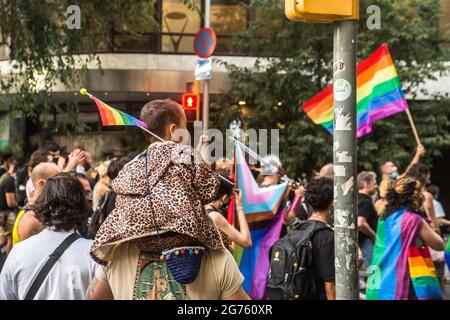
[284, 0, 359, 23]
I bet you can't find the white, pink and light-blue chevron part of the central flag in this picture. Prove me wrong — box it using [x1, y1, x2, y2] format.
[235, 144, 288, 222]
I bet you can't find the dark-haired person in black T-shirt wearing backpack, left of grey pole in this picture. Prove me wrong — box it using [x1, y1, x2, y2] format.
[302, 177, 336, 300]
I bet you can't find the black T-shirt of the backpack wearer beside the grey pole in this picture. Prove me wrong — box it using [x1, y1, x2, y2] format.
[305, 220, 335, 300]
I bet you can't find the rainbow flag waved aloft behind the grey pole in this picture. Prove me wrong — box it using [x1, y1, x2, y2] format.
[303, 43, 408, 137]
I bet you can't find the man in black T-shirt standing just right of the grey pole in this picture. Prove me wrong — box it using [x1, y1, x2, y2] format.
[356, 171, 378, 268]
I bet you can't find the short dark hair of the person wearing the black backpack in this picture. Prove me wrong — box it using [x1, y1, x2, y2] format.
[305, 177, 333, 211]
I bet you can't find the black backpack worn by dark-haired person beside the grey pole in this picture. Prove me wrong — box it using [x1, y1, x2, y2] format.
[267, 221, 331, 300]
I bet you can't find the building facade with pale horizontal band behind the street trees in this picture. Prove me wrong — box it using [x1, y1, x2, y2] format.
[0, 0, 450, 157]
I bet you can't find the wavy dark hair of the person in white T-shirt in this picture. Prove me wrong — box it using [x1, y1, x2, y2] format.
[33, 173, 90, 231]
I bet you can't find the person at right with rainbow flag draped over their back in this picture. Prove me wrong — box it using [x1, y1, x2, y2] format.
[367, 176, 444, 300]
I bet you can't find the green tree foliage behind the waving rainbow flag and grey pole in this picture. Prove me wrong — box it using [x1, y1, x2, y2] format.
[211, 0, 450, 175]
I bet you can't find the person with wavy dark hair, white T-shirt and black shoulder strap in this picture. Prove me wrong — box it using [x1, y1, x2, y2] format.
[0, 173, 96, 300]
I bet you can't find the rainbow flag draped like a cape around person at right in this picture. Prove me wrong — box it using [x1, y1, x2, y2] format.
[366, 209, 442, 300]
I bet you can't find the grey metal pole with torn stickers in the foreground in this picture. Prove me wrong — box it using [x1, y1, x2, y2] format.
[333, 20, 359, 300]
